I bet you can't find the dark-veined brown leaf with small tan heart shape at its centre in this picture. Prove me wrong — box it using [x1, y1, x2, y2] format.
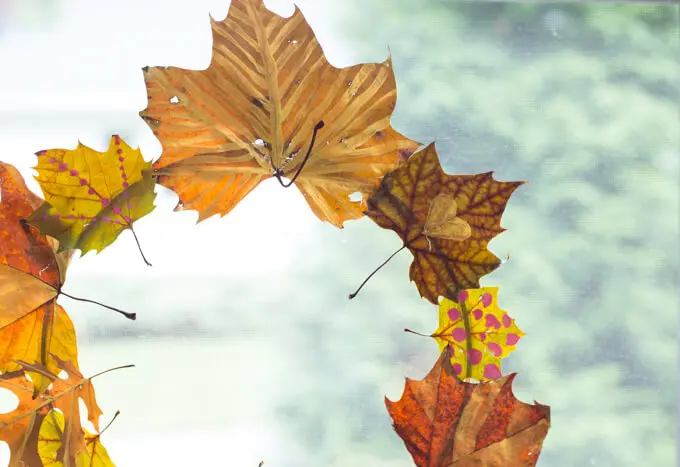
[366, 143, 524, 305]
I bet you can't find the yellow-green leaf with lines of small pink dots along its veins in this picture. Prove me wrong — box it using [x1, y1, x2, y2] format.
[27, 136, 156, 260]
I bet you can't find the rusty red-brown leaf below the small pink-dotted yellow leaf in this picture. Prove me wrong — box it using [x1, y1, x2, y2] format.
[385, 352, 550, 467]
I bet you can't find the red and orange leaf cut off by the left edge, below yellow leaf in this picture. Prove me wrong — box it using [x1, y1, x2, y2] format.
[0, 163, 78, 393]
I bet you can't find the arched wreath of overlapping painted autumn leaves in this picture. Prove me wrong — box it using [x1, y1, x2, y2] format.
[0, 0, 550, 467]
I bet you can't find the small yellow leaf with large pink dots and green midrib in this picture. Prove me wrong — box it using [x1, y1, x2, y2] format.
[432, 287, 525, 381]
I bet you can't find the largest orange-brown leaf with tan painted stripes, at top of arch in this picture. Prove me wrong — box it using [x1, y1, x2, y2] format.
[140, 0, 419, 227]
